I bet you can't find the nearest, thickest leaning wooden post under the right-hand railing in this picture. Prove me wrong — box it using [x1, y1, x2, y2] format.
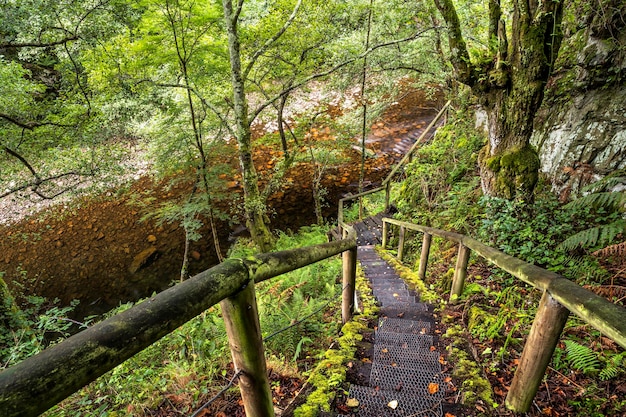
[505, 291, 569, 413]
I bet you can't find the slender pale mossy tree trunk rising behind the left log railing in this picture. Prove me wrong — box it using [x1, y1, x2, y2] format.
[222, 0, 273, 252]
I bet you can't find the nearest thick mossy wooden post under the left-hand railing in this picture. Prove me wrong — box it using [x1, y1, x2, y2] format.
[220, 280, 274, 417]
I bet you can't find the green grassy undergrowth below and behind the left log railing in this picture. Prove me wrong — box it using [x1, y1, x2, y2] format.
[2, 226, 343, 417]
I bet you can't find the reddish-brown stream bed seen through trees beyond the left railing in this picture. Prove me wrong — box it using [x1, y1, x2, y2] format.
[0, 88, 435, 319]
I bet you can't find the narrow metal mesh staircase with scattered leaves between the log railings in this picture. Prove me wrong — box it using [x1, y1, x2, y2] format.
[338, 215, 447, 417]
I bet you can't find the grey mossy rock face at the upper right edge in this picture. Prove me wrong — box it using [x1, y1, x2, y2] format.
[531, 8, 626, 199]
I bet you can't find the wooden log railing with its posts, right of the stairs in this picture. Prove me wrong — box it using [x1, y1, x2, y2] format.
[382, 218, 626, 412]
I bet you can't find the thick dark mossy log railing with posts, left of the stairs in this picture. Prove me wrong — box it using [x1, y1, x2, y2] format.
[0, 227, 356, 417]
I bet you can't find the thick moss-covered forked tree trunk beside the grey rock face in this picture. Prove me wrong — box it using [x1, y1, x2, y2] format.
[435, 0, 563, 200]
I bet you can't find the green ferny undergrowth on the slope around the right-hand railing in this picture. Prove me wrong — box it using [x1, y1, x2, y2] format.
[391, 105, 626, 416]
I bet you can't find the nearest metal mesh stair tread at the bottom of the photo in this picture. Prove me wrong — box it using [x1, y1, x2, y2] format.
[338, 385, 443, 417]
